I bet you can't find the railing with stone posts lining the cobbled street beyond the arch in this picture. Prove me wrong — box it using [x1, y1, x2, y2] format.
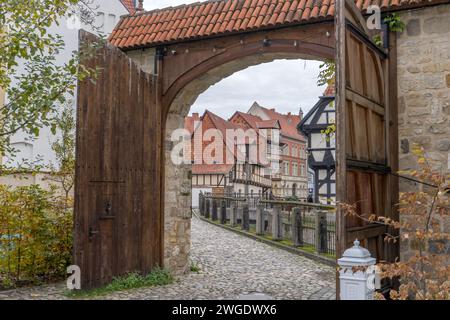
[199, 193, 336, 255]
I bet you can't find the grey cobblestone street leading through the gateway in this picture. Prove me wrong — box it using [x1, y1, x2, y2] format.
[0, 218, 335, 300]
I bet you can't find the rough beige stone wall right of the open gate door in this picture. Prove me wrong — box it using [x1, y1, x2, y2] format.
[397, 4, 450, 258]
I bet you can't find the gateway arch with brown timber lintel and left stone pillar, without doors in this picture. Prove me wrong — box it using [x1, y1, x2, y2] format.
[123, 22, 335, 273]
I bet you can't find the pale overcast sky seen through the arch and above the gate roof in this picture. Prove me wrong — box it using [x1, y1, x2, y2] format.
[144, 0, 325, 118]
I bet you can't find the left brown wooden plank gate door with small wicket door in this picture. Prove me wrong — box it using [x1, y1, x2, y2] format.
[74, 31, 162, 289]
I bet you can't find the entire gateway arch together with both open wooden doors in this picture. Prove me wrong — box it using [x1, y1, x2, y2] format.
[75, 0, 398, 287]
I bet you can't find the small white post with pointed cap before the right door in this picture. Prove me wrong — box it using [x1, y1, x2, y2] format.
[338, 239, 376, 300]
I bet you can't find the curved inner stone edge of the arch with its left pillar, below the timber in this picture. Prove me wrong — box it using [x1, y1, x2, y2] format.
[163, 49, 333, 273]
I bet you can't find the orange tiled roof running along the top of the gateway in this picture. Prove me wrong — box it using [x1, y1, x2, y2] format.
[109, 0, 443, 49]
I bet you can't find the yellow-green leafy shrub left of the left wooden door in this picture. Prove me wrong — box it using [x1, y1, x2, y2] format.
[0, 185, 73, 288]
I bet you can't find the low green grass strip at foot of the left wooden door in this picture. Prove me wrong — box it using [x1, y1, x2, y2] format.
[65, 268, 174, 298]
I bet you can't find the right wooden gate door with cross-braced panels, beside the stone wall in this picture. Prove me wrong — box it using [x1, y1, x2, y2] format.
[335, 0, 398, 261]
